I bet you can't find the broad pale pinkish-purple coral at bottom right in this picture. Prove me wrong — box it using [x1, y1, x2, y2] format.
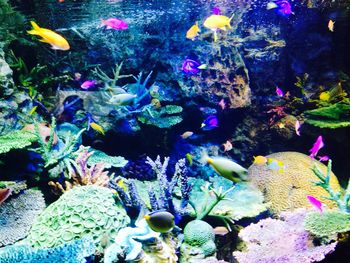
[233, 209, 337, 263]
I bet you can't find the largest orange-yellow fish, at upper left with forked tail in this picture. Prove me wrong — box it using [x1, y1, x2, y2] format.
[27, 21, 70, 50]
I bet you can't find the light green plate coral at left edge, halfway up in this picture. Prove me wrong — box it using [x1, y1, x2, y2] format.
[0, 131, 37, 154]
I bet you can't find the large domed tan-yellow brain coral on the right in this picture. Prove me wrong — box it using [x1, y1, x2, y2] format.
[248, 152, 341, 216]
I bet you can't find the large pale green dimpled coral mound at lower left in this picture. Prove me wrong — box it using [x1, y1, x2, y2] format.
[28, 185, 130, 252]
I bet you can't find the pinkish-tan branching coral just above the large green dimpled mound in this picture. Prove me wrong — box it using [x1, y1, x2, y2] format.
[49, 146, 109, 194]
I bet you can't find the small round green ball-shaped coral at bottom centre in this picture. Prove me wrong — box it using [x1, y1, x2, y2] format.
[181, 220, 216, 263]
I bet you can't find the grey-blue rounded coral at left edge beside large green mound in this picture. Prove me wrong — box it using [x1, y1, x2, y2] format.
[0, 189, 45, 248]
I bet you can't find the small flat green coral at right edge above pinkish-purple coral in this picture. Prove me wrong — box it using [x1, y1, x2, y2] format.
[304, 210, 350, 238]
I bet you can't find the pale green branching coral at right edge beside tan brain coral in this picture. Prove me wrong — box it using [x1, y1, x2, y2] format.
[312, 160, 350, 213]
